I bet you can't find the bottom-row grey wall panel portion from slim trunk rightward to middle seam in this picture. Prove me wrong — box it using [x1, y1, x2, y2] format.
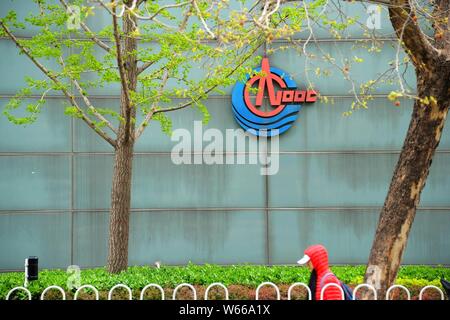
[130, 211, 266, 264]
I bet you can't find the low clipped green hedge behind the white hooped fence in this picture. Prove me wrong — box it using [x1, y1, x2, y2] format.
[0, 264, 450, 299]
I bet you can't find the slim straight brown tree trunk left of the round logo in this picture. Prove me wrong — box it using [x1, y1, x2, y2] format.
[107, 8, 137, 273]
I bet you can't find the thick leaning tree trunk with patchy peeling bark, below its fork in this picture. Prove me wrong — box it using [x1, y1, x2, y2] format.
[365, 67, 450, 299]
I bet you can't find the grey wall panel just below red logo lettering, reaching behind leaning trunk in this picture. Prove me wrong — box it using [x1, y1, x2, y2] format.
[280, 97, 450, 151]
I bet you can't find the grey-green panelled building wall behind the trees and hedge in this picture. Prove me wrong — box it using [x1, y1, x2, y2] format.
[0, 1, 450, 271]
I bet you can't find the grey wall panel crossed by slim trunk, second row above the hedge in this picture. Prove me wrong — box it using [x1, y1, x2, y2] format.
[75, 154, 264, 209]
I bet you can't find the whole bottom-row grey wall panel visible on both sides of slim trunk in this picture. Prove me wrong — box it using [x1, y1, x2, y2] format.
[74, 211, 265, 267]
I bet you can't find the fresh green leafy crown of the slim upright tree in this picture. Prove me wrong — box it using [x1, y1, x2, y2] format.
[0, 0, 304, 133]
